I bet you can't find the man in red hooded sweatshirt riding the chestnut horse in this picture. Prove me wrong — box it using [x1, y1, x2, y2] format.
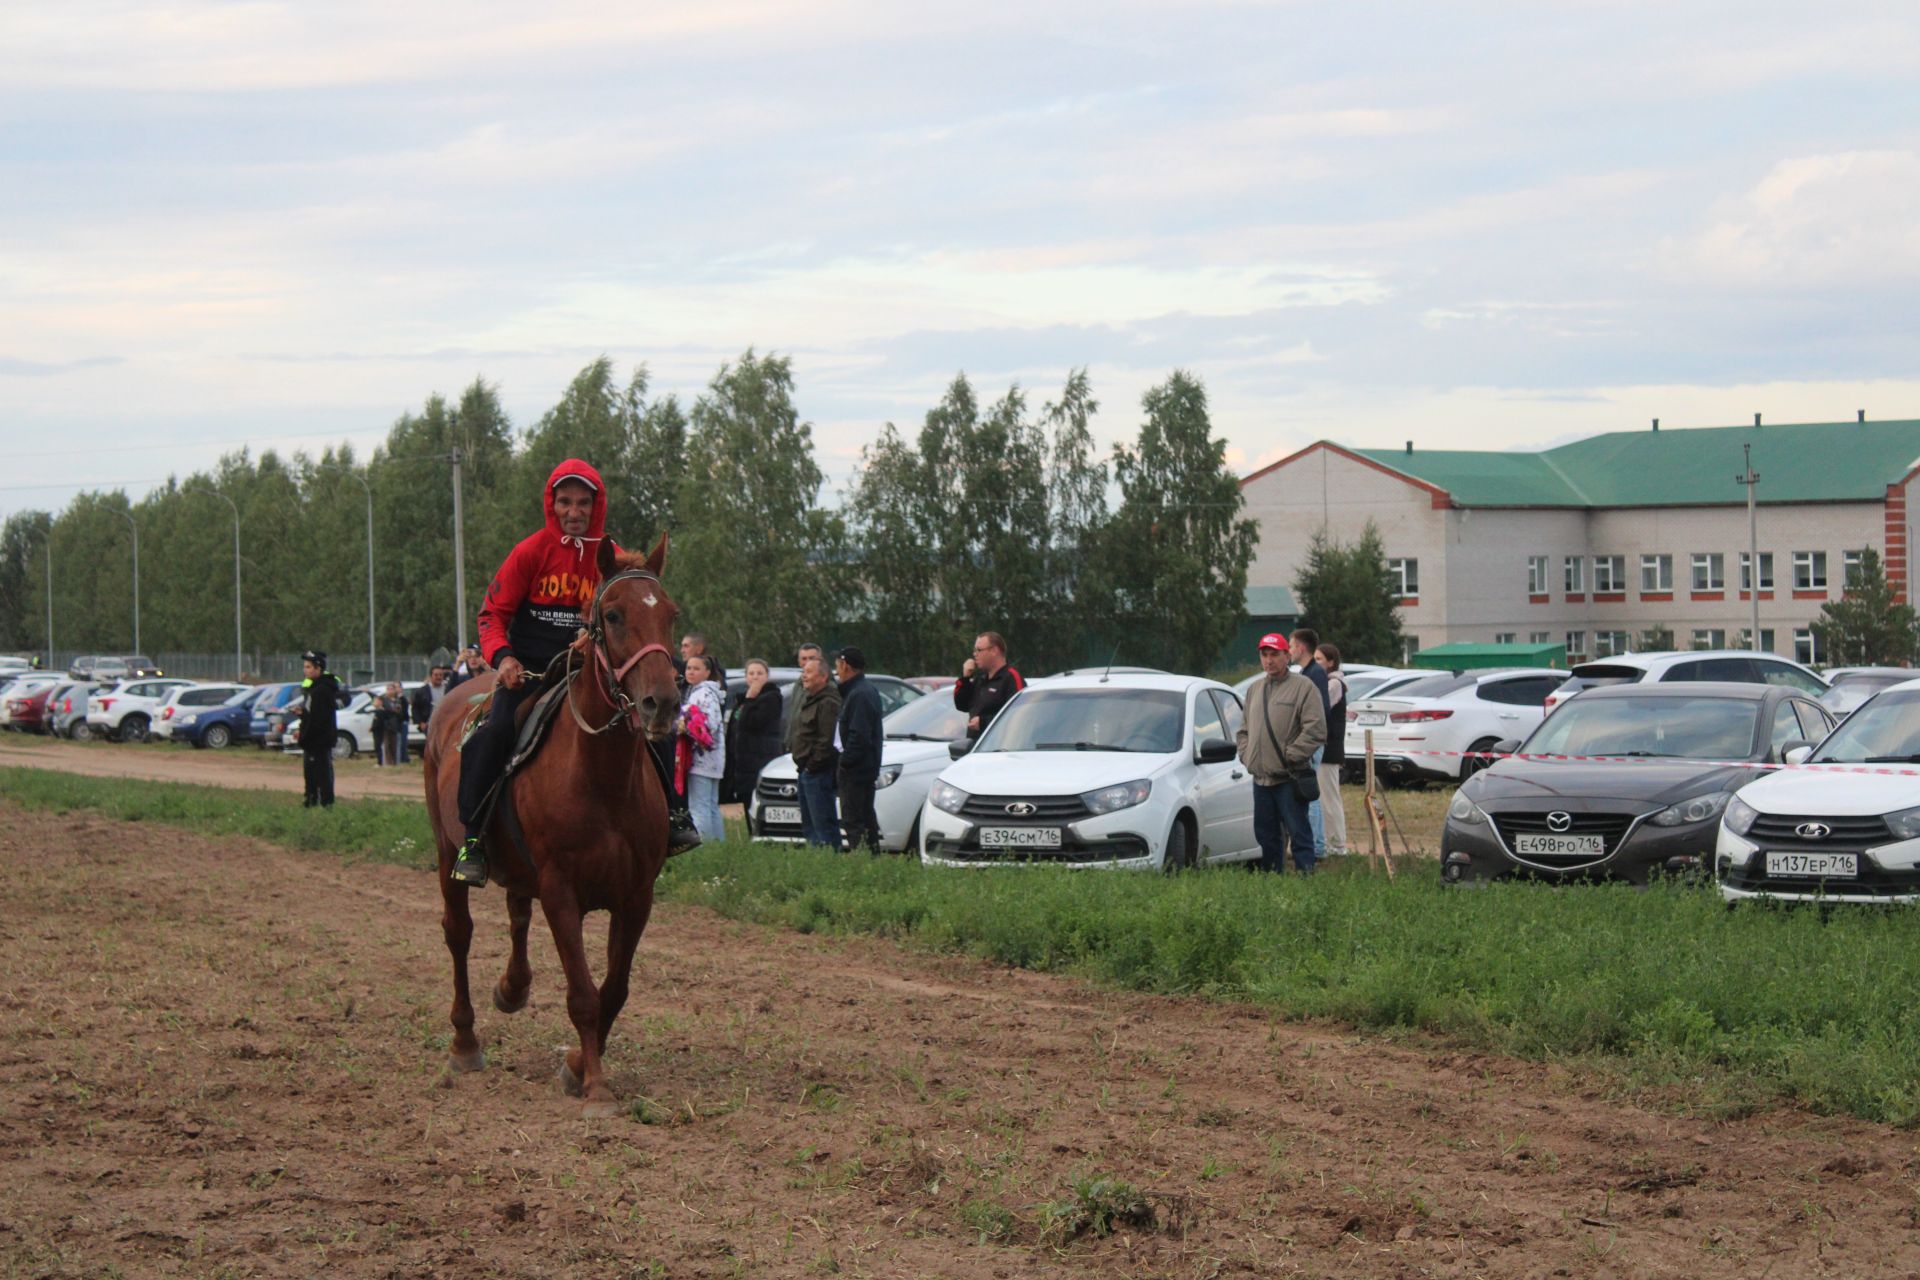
[453, 459, 699, 887]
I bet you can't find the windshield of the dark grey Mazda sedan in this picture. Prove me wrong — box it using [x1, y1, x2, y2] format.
[1521, 697, 1764, 760]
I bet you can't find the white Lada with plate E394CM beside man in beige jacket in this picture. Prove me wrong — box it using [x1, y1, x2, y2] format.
[920, 674, 1260, 871]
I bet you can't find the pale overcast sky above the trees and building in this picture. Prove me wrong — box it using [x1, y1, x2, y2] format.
[0, 0, 1920, 512]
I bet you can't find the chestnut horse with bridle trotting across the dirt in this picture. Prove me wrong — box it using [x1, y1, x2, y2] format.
[424, 533, 680, 1117]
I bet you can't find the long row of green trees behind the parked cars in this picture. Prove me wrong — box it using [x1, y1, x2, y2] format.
[0, 349, 1256, 674]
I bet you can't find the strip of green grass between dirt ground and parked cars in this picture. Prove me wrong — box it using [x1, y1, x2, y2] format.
[0, 770, 1920, 1126]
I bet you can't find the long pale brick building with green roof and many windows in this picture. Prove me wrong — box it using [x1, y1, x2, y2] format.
[1240, 420, 1920, 662]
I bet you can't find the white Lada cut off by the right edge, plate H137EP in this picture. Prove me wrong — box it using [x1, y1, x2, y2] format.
[1715, 679, 1920, 902]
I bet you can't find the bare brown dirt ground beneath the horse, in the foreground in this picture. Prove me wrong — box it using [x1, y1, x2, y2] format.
[0, 806, 1920, 1280]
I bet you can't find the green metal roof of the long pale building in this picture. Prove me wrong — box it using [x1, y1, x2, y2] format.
[1354, 418, 1920, 507]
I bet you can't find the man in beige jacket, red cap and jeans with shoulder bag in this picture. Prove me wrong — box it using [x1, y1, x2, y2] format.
[1236, 635, 1327, 875]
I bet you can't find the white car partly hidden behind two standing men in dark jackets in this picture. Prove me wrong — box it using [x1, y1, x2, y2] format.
[747, 691, 966, 852]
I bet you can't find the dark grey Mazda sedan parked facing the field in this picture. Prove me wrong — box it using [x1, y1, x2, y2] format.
[1440, 683, 1834, 885]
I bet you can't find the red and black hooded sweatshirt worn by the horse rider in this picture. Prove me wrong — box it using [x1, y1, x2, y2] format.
[480, 459, 618, 674]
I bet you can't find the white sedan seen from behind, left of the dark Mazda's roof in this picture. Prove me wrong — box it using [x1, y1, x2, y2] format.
[1346, 666, 1567, 781]
